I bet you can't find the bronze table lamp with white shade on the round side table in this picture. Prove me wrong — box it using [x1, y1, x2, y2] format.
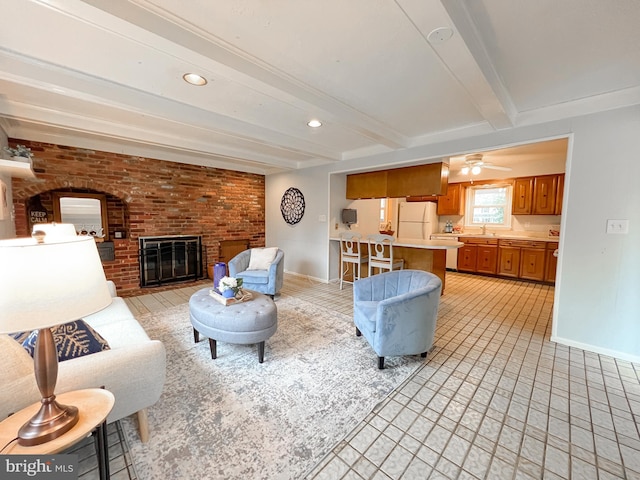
[0, 230, 111, 446]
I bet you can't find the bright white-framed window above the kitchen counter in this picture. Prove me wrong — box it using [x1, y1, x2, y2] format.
[465, 185, 511, 228]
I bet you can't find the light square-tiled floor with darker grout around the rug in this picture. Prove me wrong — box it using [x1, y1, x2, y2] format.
[82, 273, 640, 480]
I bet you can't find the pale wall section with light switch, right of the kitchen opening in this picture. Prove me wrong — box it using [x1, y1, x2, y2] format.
[552, 107, 640, 361]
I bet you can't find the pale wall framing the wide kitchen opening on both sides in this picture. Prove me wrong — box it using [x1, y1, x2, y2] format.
[266, 106, 640, 362]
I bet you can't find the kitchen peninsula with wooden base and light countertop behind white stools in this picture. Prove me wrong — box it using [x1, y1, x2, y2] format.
[329, 235, 464, 292]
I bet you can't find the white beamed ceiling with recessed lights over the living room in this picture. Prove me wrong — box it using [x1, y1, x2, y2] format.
[0, 0, 640, 174]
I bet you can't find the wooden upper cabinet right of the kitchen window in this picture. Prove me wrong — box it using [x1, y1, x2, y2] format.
[511, 174, 564, 215]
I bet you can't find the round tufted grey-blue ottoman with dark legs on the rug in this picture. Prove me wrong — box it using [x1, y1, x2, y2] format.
[189, 288, 278, 363]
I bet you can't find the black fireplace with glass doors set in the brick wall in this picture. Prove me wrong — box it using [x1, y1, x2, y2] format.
[139, 235, 203, 287]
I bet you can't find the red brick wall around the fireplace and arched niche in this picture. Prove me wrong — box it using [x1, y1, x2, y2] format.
[9, 139, 265, 296]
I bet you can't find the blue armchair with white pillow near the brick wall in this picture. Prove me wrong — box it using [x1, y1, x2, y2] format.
[229, 249, 284, 298]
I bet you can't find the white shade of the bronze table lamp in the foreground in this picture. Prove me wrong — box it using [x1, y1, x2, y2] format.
[0, 234, 111, 333]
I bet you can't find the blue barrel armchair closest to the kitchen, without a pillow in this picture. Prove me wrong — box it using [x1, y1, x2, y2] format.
[353, 270, 442, 369]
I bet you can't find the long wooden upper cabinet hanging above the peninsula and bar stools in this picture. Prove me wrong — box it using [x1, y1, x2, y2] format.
[347, 162, 449, 200]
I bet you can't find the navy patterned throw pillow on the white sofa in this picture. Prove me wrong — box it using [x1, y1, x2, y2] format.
[11, 320, 109, 362]
